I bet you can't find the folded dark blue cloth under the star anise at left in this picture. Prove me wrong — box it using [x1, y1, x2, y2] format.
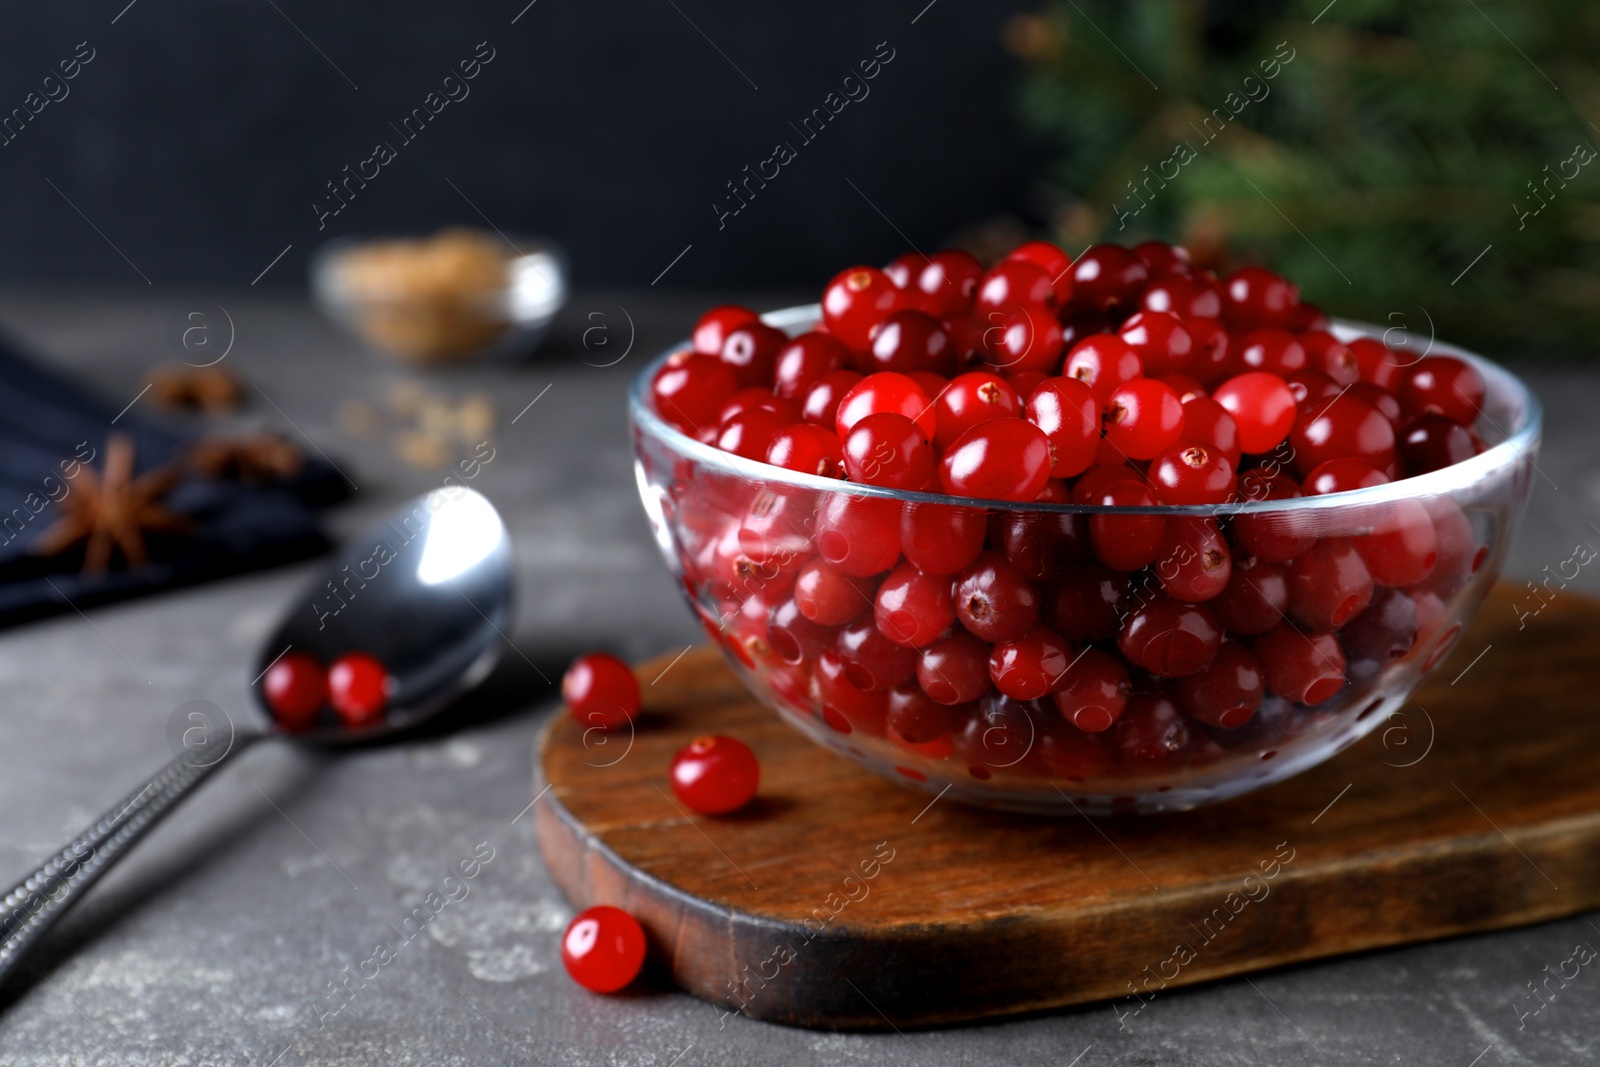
[0, 329, 347, 625]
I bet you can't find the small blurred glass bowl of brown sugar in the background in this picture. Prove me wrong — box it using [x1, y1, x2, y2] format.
[310, 229, 568, 365]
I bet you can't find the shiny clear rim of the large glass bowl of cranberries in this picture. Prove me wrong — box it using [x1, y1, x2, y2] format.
[627, 304, 1544, 517]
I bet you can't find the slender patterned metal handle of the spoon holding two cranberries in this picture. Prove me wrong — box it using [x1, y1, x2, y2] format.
[0, 733, 261, 982]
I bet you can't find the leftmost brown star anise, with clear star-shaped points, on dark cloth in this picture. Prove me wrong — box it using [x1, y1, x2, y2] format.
[30, 434, 189, 574]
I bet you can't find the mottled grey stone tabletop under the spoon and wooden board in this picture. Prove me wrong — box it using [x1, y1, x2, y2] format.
[0, 293, 1600, 1067]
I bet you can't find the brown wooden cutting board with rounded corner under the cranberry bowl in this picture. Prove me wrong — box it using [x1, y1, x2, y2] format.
[534, 587, 1600, 1029]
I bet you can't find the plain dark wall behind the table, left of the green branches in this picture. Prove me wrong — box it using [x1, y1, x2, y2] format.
[0, 0, 1030, 288]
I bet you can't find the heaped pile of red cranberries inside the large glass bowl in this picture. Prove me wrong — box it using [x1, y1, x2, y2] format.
[651, 242, 1486, 793]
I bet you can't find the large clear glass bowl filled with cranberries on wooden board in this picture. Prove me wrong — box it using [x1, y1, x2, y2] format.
[629, 306, 1541, 814]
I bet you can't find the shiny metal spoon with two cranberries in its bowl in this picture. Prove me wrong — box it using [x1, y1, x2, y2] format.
[0, 488, 512, 981]
